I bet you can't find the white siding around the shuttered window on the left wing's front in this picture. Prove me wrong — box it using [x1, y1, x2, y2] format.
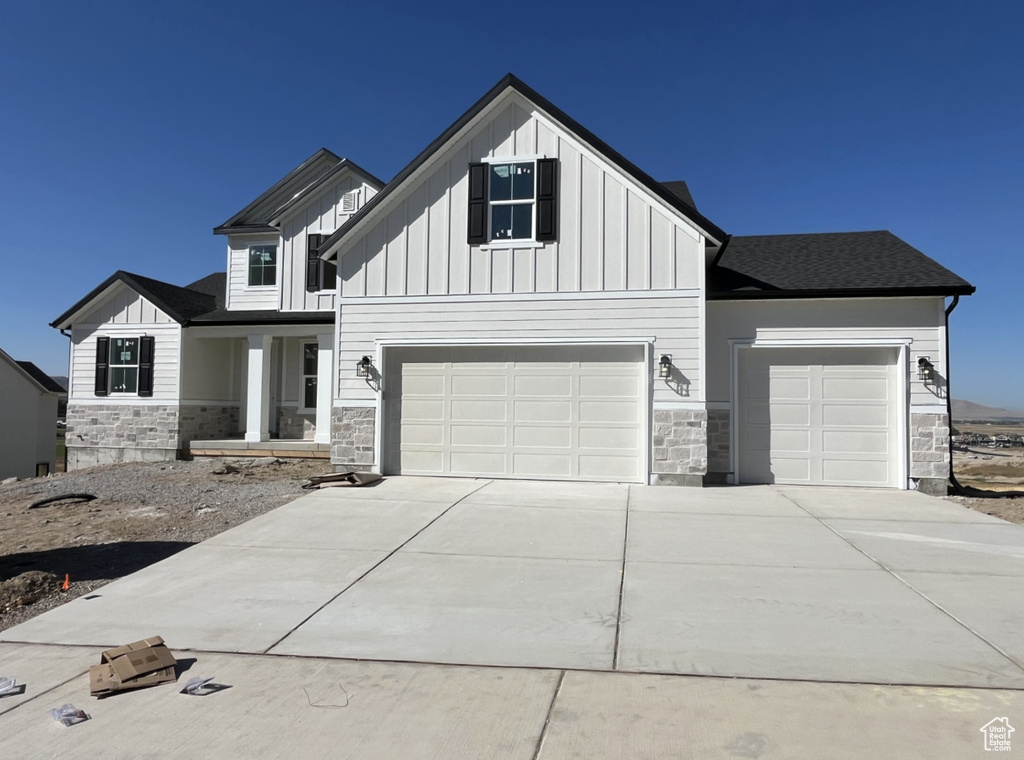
[68, 284, 181, 404]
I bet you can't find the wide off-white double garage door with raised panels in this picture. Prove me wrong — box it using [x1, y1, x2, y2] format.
[384, 346, 647, 482]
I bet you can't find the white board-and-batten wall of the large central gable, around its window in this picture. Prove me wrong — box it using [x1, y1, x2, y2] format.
[329, 88, 706, 297]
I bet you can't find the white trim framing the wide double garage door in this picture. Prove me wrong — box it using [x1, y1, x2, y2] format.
[374, 337, 654, 484]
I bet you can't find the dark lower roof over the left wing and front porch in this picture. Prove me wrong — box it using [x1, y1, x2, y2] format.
[50, 269, 334, 328]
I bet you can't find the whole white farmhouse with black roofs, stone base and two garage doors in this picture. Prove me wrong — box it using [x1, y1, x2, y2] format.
[54, 75, 974, 492]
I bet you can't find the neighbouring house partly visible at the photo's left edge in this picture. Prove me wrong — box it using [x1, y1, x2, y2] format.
[0, 350, 65, 479]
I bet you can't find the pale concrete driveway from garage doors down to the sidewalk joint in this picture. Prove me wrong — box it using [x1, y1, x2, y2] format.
[0, 477, 1024, 689]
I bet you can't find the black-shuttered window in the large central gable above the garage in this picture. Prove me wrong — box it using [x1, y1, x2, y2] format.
[468, 158, 558, 247]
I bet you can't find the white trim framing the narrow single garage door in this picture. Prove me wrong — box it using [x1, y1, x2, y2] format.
[728, 338, 913, 490]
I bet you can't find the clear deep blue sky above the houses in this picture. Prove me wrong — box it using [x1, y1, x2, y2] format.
[0, 0, 1024, 409]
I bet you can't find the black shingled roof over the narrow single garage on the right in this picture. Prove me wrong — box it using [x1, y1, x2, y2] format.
[708, 230, 975, 300]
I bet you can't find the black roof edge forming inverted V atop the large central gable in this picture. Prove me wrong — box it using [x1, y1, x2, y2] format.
[321, 74, 727, 258]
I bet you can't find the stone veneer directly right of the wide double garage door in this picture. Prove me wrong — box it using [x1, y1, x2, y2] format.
[651, 409, 708, 485]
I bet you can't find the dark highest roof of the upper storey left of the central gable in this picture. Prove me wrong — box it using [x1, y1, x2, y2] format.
[213, 147, 384, 235]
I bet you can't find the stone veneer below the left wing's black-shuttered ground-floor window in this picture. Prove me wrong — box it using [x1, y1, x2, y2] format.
[65, 404, 178, 470]
